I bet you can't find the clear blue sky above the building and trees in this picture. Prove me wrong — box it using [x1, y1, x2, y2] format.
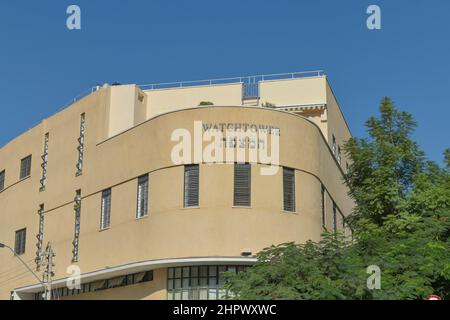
[0, 0, 450, 162]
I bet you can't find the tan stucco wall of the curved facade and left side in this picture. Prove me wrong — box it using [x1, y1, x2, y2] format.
[0, 81, 352, 299]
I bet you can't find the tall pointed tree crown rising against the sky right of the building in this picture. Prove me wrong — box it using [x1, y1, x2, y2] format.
[344, 97, 424, 225]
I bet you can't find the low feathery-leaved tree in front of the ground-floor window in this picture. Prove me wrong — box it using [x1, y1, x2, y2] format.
[226, 233, 366, 300]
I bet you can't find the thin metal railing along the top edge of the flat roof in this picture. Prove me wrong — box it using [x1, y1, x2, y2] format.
[139, 70, 324, 90]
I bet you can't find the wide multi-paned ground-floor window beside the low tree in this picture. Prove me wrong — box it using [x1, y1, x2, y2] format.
[167, 265, 247, 300]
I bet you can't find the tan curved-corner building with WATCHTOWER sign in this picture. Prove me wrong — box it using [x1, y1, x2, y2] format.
[0, 72, 353, 299]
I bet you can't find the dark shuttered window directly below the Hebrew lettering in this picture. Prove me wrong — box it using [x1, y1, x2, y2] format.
[233, 163, 251, 207]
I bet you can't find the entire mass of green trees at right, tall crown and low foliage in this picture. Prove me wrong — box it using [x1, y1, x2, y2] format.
[227, 98, 450, 299]
